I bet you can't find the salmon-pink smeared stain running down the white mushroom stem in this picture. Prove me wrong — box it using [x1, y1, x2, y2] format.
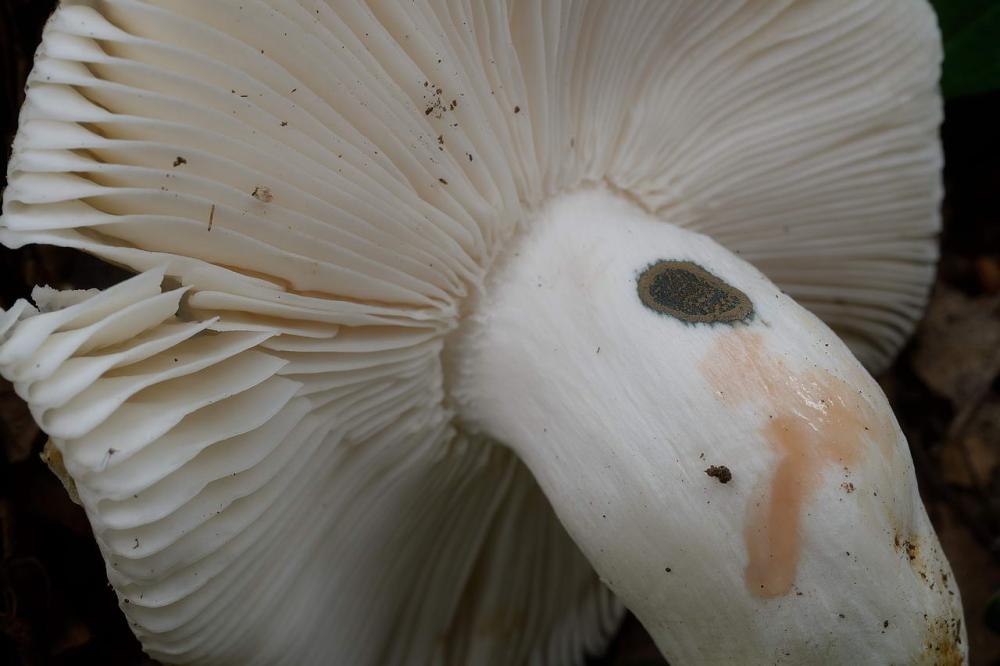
[701, 331, 895, 598]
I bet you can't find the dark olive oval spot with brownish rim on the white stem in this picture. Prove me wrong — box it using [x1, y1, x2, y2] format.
[638, 260, 753, 324]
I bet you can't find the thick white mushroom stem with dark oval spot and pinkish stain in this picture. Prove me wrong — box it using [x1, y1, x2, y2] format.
[454, 185, 965, 664]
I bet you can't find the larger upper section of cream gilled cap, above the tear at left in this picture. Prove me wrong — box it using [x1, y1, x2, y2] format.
[2, 0, 941, 370]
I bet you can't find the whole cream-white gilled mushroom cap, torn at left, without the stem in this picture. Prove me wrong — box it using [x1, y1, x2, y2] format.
[0, 0, 941, 664]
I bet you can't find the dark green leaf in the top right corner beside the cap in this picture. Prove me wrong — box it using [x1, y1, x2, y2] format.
[931, 0, 1000, 99]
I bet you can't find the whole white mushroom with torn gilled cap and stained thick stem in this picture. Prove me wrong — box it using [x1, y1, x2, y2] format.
[0, 0, 966, 664]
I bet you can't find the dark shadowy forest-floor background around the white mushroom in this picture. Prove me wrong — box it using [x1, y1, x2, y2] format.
[0, 0, 1000, 666]
